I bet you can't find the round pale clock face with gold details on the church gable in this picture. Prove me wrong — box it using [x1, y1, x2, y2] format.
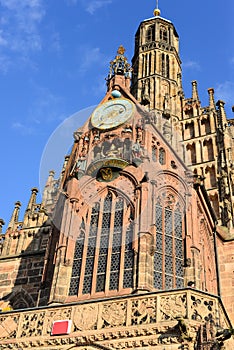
[91, 98, 135, 129]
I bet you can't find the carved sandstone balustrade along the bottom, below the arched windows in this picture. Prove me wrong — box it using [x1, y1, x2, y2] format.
[0, 288, 233, 350]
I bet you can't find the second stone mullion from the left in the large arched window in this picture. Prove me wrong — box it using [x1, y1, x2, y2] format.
[90, 198, 104, 294]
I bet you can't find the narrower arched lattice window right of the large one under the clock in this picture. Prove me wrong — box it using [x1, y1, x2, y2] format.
[154, 195, 183, 290]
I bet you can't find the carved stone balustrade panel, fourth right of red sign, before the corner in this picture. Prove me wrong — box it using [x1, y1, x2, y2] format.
[160, 294, 186, 321]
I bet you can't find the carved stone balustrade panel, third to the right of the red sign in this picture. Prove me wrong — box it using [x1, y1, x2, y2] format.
[132, 298, 156, 325]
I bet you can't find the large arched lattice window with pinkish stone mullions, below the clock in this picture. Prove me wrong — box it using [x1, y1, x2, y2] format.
[69, 191, 134, 295]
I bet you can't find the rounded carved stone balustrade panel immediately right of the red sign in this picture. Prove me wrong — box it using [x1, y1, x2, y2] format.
[73, 305, 98, 331]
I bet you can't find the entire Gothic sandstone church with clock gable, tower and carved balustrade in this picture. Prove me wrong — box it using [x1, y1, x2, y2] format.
[0, 3, 234, 350]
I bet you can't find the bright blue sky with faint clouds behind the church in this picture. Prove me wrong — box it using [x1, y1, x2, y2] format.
[0, 0, 234, 228]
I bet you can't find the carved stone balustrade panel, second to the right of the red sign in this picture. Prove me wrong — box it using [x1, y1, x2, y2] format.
[102, 302, 126, 327]
